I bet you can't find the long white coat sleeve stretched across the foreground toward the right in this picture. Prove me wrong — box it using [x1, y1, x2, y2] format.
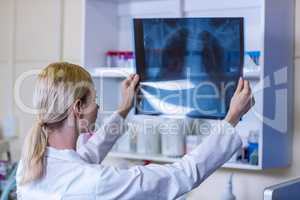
[97, 121, 242, 200]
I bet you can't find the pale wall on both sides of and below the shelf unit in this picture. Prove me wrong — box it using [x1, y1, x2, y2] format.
[0, 0, 300, 200]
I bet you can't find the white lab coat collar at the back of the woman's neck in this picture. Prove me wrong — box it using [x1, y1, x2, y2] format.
[46, 147, 84, 163]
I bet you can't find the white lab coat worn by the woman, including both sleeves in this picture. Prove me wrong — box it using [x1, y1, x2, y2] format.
[17, 114, 242, 200]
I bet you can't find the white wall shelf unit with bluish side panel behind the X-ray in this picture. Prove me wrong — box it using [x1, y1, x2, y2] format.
[82, 0, 295, 170]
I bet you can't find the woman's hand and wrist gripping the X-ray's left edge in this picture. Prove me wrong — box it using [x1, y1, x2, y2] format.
[117, 74, 139, 118]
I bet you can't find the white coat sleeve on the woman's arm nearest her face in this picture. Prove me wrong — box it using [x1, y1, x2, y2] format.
[77, 112, 127, 164]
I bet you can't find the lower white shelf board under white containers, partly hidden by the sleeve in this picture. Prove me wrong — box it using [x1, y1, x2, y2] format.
[108, 152, 261, 170]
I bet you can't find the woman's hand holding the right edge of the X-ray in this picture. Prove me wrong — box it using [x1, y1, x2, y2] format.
[225, 78, 255, 127]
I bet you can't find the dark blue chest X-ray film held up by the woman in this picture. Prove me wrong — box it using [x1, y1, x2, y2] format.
[133, 18, 244, 119]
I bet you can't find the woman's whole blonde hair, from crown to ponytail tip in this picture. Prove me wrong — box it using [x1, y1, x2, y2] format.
[21, 62, 93, 184]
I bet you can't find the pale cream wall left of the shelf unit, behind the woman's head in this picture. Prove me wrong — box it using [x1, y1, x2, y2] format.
[0, 0, 82, 159]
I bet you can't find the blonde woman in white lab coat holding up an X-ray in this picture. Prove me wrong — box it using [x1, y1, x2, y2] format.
[17, 63, 251, 200]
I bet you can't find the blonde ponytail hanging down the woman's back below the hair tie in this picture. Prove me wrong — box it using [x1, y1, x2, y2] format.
[21, 119, 48, 184]
